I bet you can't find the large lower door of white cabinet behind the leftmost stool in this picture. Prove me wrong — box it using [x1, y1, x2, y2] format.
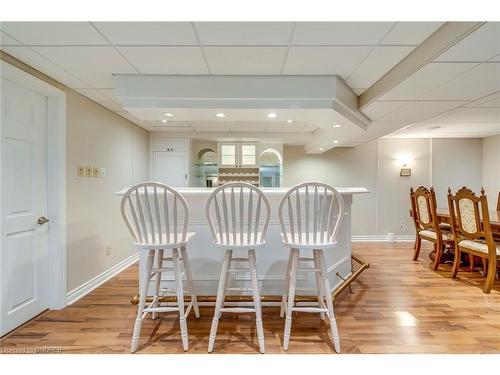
[153, 151, 187, 187]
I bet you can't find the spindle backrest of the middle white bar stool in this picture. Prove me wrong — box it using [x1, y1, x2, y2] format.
[206, 182, 271, 246]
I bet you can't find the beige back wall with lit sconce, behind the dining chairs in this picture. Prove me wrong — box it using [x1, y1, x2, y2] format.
[284, 138, 483, 236]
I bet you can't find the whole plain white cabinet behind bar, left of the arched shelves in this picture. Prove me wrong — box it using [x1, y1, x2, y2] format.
[149, 137, 189, 187]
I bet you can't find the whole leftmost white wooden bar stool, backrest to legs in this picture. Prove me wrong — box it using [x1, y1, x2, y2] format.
[121, 182, 200, 353]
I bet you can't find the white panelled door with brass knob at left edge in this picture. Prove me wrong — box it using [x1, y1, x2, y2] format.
[0, 79, 49, 335]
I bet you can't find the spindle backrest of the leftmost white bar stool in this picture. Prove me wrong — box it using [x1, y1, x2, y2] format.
[121, 182, 189, 245]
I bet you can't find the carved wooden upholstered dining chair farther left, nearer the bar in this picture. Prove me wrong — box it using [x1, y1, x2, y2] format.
[410, 186, 453, 270]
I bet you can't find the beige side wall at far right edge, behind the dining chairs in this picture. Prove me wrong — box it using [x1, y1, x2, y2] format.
[483, 135, 500, 210]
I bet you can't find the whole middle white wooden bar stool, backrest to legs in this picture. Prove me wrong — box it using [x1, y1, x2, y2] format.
[206, 182, 271, 353]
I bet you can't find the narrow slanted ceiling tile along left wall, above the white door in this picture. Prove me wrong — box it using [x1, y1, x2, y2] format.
[2, 46, 89, 88]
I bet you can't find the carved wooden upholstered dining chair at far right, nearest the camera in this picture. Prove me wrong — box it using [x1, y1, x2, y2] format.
[448, 186, 500, 293]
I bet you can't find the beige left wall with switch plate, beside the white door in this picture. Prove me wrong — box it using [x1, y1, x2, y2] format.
[0, 51, 149, 291]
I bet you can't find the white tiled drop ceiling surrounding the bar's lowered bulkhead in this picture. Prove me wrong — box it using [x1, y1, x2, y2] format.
[0, 22, 500, 145]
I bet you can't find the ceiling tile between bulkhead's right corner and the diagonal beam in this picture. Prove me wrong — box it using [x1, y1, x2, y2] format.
[347, 46, 414, 87]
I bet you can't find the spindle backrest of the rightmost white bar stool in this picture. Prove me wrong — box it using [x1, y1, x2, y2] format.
[278, 182, 344, 245]
